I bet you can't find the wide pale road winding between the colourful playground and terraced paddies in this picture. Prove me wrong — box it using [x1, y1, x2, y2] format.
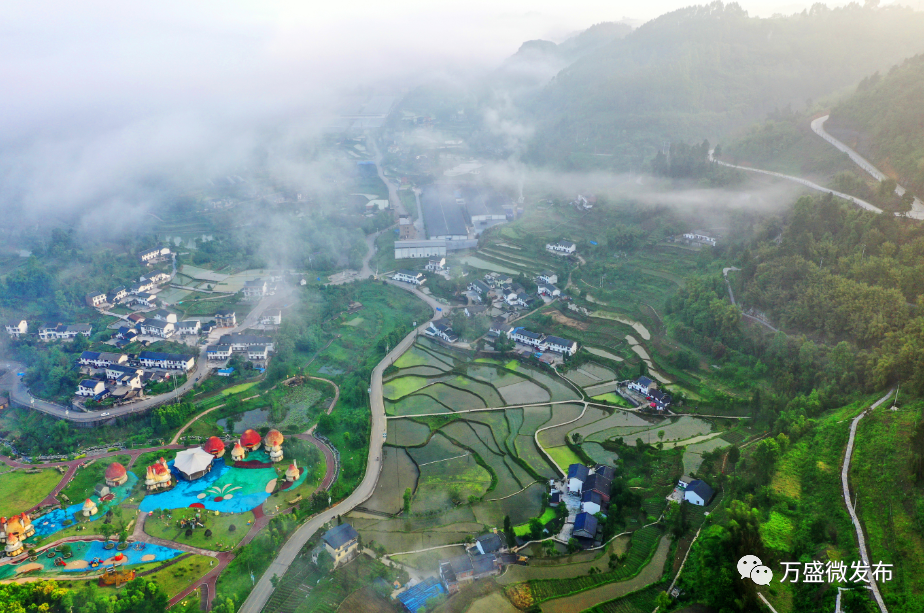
[238, 281, 444, 613]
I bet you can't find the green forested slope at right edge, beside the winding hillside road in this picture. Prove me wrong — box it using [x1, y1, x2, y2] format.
[825, 55, 924, 196]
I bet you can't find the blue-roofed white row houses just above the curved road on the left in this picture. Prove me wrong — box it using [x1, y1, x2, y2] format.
[74, 351, 196, 401]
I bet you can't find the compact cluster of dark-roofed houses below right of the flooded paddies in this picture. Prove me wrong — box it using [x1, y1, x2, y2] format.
[549, 464, 616, 548]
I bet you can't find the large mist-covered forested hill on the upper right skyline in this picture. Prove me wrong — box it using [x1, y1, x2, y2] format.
[529, 2, 924, 169]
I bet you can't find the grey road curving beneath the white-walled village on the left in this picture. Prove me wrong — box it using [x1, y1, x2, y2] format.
[0, 292, 287, 423]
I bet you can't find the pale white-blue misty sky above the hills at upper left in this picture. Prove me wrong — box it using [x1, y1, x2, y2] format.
[0, 0, 904, 225]
